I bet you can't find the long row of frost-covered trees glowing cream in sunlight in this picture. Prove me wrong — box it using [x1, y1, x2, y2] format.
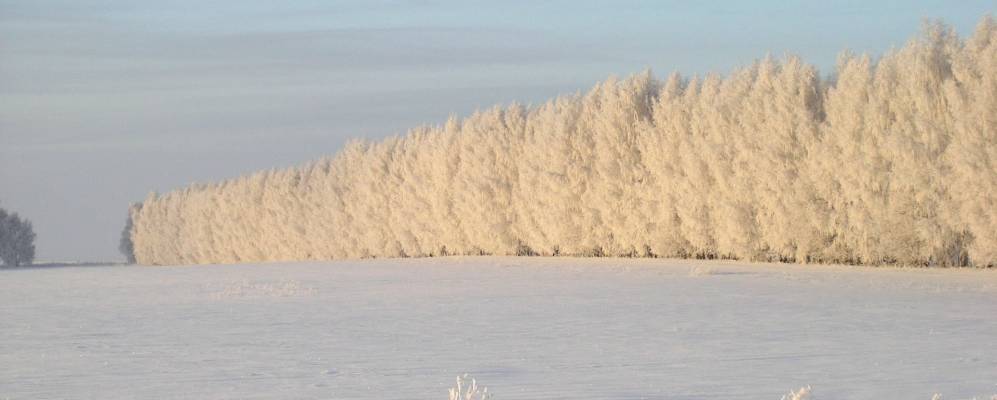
[122, 17, 997, 266]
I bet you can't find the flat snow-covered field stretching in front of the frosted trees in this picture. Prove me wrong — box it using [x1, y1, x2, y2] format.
[0, 257, 997, 400]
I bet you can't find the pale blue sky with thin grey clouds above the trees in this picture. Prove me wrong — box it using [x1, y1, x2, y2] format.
[0, 0, 997, 261]
